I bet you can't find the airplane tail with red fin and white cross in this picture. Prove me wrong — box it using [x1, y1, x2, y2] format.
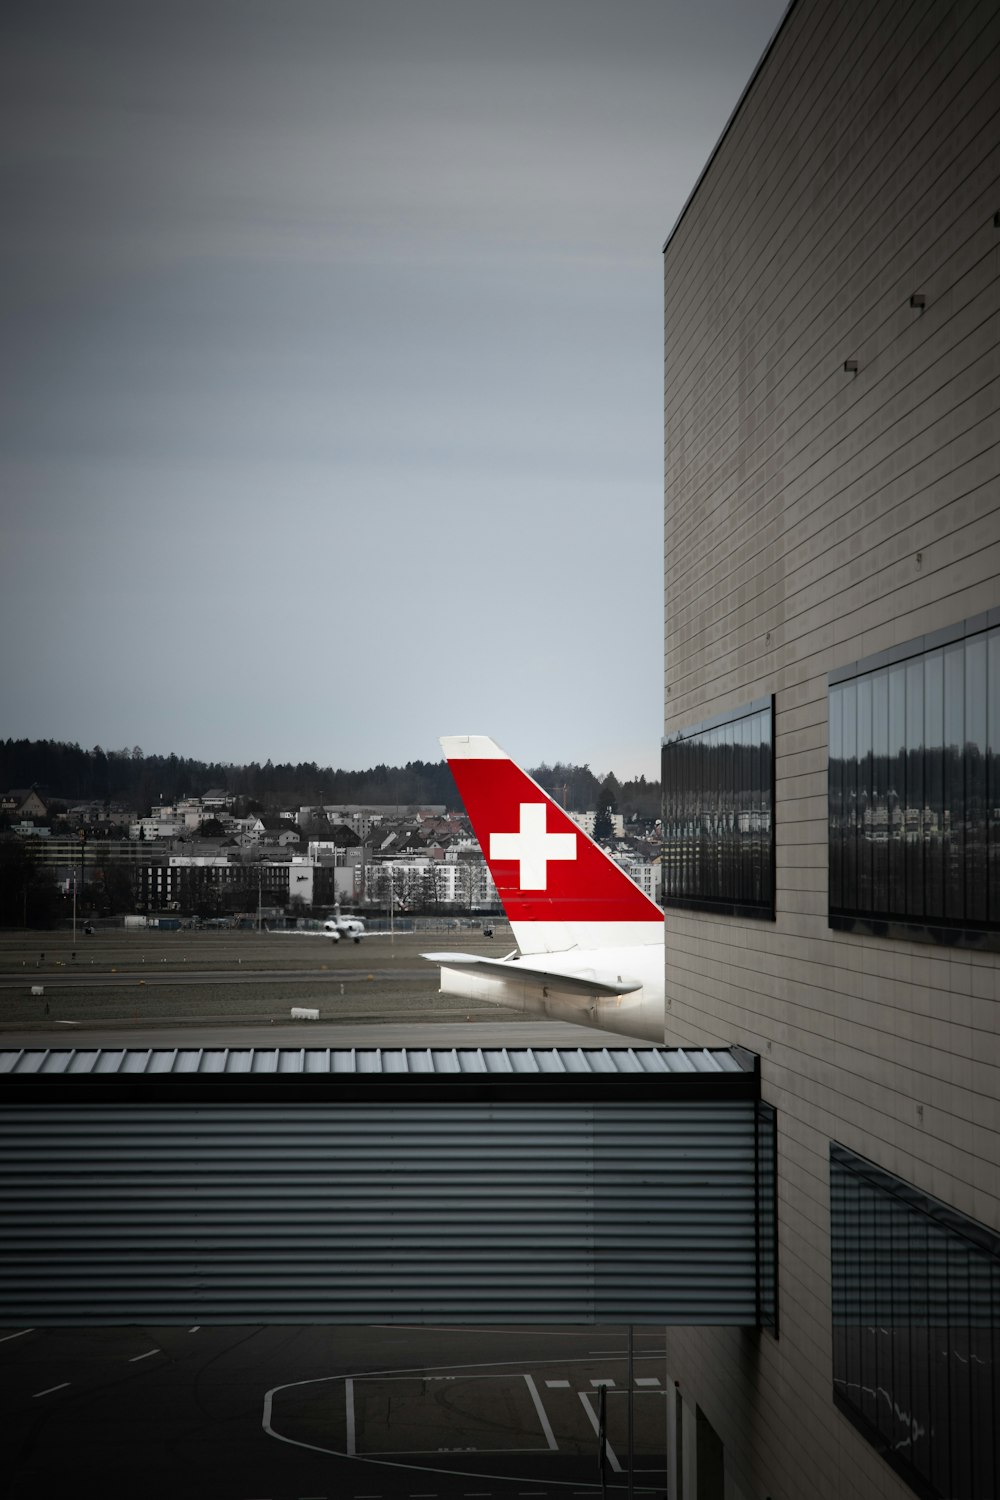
[424, 735, 666, 1044]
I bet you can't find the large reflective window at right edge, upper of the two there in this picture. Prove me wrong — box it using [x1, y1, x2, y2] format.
[829, 627, 1000, 948]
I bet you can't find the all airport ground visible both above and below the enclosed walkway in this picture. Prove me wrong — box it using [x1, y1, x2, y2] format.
[0, 930, 656, 1500]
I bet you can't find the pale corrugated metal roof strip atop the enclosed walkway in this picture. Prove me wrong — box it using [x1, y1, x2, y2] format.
[0, 1047, 753, 1077]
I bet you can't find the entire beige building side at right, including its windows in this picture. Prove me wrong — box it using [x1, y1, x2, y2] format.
[663, 0, 1000, 1500]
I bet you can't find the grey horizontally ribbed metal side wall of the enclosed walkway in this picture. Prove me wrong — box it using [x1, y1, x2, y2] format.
[0, 1100, 759, 1326]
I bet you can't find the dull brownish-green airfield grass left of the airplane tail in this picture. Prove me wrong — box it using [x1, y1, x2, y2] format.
[0, 927, 519, 1034]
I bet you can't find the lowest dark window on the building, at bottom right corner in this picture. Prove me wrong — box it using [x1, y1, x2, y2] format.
[831, 1145, 1000, 1500]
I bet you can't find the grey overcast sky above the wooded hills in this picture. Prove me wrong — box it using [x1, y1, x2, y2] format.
[0, 0, 784, 777]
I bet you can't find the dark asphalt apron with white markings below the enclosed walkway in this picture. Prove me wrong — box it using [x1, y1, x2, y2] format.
[0, 1326, 666, 1500]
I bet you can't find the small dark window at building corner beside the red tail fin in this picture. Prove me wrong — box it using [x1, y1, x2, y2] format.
[663, 701, 774, 917]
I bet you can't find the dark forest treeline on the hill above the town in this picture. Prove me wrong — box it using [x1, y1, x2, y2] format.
[0, 740, 660, 818]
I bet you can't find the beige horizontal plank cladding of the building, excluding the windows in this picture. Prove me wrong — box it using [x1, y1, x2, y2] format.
[664, 0, 1000, 1500]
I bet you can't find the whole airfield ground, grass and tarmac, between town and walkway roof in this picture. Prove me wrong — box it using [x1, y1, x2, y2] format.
[0, 929, 638, 1047]
